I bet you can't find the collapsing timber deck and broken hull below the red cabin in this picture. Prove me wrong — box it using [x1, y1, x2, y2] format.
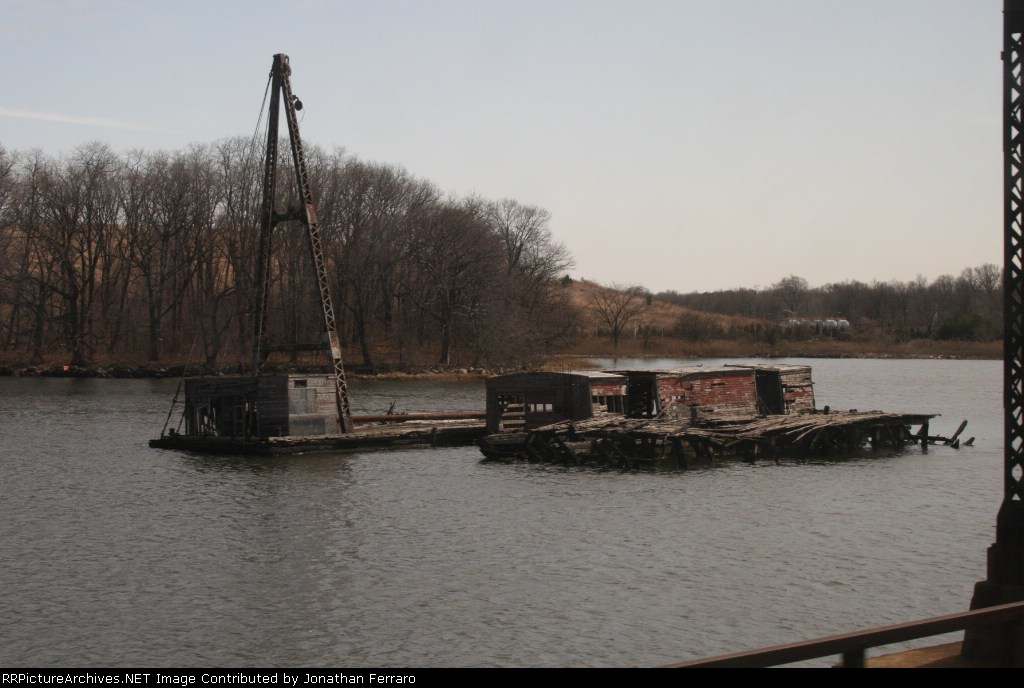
[480, 411, 942, 467]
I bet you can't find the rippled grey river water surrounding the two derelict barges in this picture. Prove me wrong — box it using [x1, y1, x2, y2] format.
[0, 360, 1002, 667]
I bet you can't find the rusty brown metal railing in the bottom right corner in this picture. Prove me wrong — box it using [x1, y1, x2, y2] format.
[666, 602, 1024, 669]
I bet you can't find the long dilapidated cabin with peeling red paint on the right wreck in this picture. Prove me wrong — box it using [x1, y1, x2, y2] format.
[486, 364, 814, 432]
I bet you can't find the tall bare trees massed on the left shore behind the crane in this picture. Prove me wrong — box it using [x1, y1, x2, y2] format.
[0, 138, 575, 369]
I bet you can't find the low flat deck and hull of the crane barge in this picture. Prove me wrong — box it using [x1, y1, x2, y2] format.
[150, 420, 486, 457]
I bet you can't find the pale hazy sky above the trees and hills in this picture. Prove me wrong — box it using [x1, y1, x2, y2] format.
[0, 0, 1002, 292]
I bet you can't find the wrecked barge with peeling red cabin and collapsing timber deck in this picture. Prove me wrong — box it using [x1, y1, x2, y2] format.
[480, 366, 966, 466]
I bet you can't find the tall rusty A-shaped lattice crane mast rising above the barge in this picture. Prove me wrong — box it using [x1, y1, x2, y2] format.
[252, 53, 352, 433]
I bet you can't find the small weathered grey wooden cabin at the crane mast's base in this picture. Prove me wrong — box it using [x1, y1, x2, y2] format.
[184, 375, 340, 439]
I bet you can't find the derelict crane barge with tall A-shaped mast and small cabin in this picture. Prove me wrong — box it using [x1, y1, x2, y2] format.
[150, 53, 484, 455]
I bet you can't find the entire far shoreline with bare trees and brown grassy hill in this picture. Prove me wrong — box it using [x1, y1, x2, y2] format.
[0, 139, 1005, 377]
